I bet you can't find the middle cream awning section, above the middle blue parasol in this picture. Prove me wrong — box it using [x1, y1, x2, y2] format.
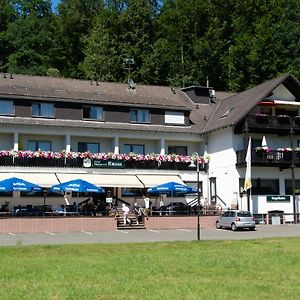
[56, 173, 144, 188]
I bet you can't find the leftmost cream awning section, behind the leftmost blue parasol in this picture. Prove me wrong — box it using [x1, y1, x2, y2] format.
[0, 172, 59, 187]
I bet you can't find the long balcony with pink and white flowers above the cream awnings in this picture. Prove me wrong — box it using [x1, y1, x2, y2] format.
[0, 151, 207, 171]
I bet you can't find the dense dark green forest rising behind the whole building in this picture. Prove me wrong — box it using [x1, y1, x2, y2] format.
[0, 0, 300, 91]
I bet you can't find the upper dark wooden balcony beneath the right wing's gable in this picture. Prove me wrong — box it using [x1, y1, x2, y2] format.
[235, 114, 300, 134]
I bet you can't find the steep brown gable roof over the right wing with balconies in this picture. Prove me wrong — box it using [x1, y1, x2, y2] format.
[202, 74, 300, 133]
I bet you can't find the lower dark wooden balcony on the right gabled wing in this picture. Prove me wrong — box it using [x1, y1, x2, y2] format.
[236, 150, 300, 169]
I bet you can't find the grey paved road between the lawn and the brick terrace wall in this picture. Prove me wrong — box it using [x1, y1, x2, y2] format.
[0, 224, 300, 246]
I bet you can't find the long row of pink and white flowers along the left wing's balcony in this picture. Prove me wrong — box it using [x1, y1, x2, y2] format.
[0, 150, 209, 163]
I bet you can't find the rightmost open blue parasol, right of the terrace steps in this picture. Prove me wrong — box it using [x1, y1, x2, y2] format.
[147, 181, 197, 196]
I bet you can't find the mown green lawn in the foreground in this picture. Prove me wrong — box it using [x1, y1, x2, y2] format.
[0, 238, 300, 300]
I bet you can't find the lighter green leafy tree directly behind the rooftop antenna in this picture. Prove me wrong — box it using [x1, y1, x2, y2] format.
[81, 0, 157, 82]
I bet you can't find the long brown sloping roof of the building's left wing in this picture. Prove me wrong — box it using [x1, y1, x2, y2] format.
[0, 74, 189, 111]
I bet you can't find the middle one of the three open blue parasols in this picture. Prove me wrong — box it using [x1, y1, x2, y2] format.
[51, 179, 105, 193]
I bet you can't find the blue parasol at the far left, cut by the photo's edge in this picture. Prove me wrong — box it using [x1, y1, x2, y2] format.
[0, 177, 42, 192]
